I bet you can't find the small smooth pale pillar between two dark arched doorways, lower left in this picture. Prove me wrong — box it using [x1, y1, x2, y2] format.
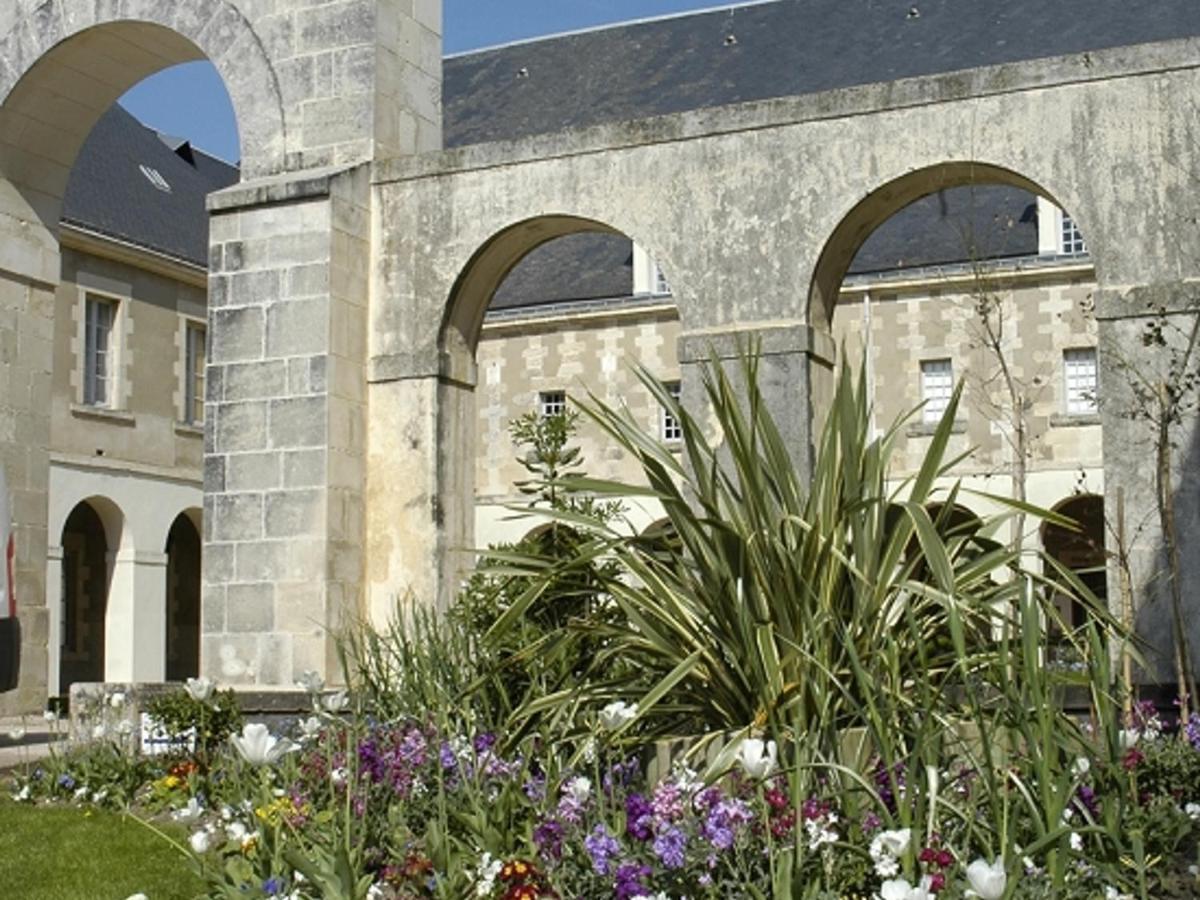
[104, 550, 167, 682]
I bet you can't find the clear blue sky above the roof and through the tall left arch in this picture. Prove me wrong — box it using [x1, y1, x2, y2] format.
[120, 0, 721, 161]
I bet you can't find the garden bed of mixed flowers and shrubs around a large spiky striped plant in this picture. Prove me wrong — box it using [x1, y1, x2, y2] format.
[7, 353, 1200, 900]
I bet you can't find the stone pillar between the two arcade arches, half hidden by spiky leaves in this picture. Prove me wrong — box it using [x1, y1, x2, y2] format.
[679, 324, 834, 476]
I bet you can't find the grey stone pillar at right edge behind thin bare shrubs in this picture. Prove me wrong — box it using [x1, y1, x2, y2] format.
[1097, 282, 1200, 690]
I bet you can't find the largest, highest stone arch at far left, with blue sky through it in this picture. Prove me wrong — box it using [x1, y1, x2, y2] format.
[0, 0, 286, 241]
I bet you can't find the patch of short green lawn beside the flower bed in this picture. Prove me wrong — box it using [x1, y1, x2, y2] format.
[0, 799, 204, 900]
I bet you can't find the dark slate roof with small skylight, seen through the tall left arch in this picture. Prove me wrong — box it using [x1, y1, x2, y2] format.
[62, 103, 238, 266]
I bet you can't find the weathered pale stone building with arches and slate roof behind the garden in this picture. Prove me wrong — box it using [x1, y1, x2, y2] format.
[0, 0, 1200, 706]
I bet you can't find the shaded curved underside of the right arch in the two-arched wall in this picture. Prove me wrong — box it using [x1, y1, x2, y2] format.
[806, 161, 1086, 331]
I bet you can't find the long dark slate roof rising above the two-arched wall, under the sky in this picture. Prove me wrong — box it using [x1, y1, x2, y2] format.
[443, 0, 1200, 146]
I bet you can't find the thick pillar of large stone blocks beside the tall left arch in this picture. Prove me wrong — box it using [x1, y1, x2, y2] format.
[200, 167, 370, 685]
